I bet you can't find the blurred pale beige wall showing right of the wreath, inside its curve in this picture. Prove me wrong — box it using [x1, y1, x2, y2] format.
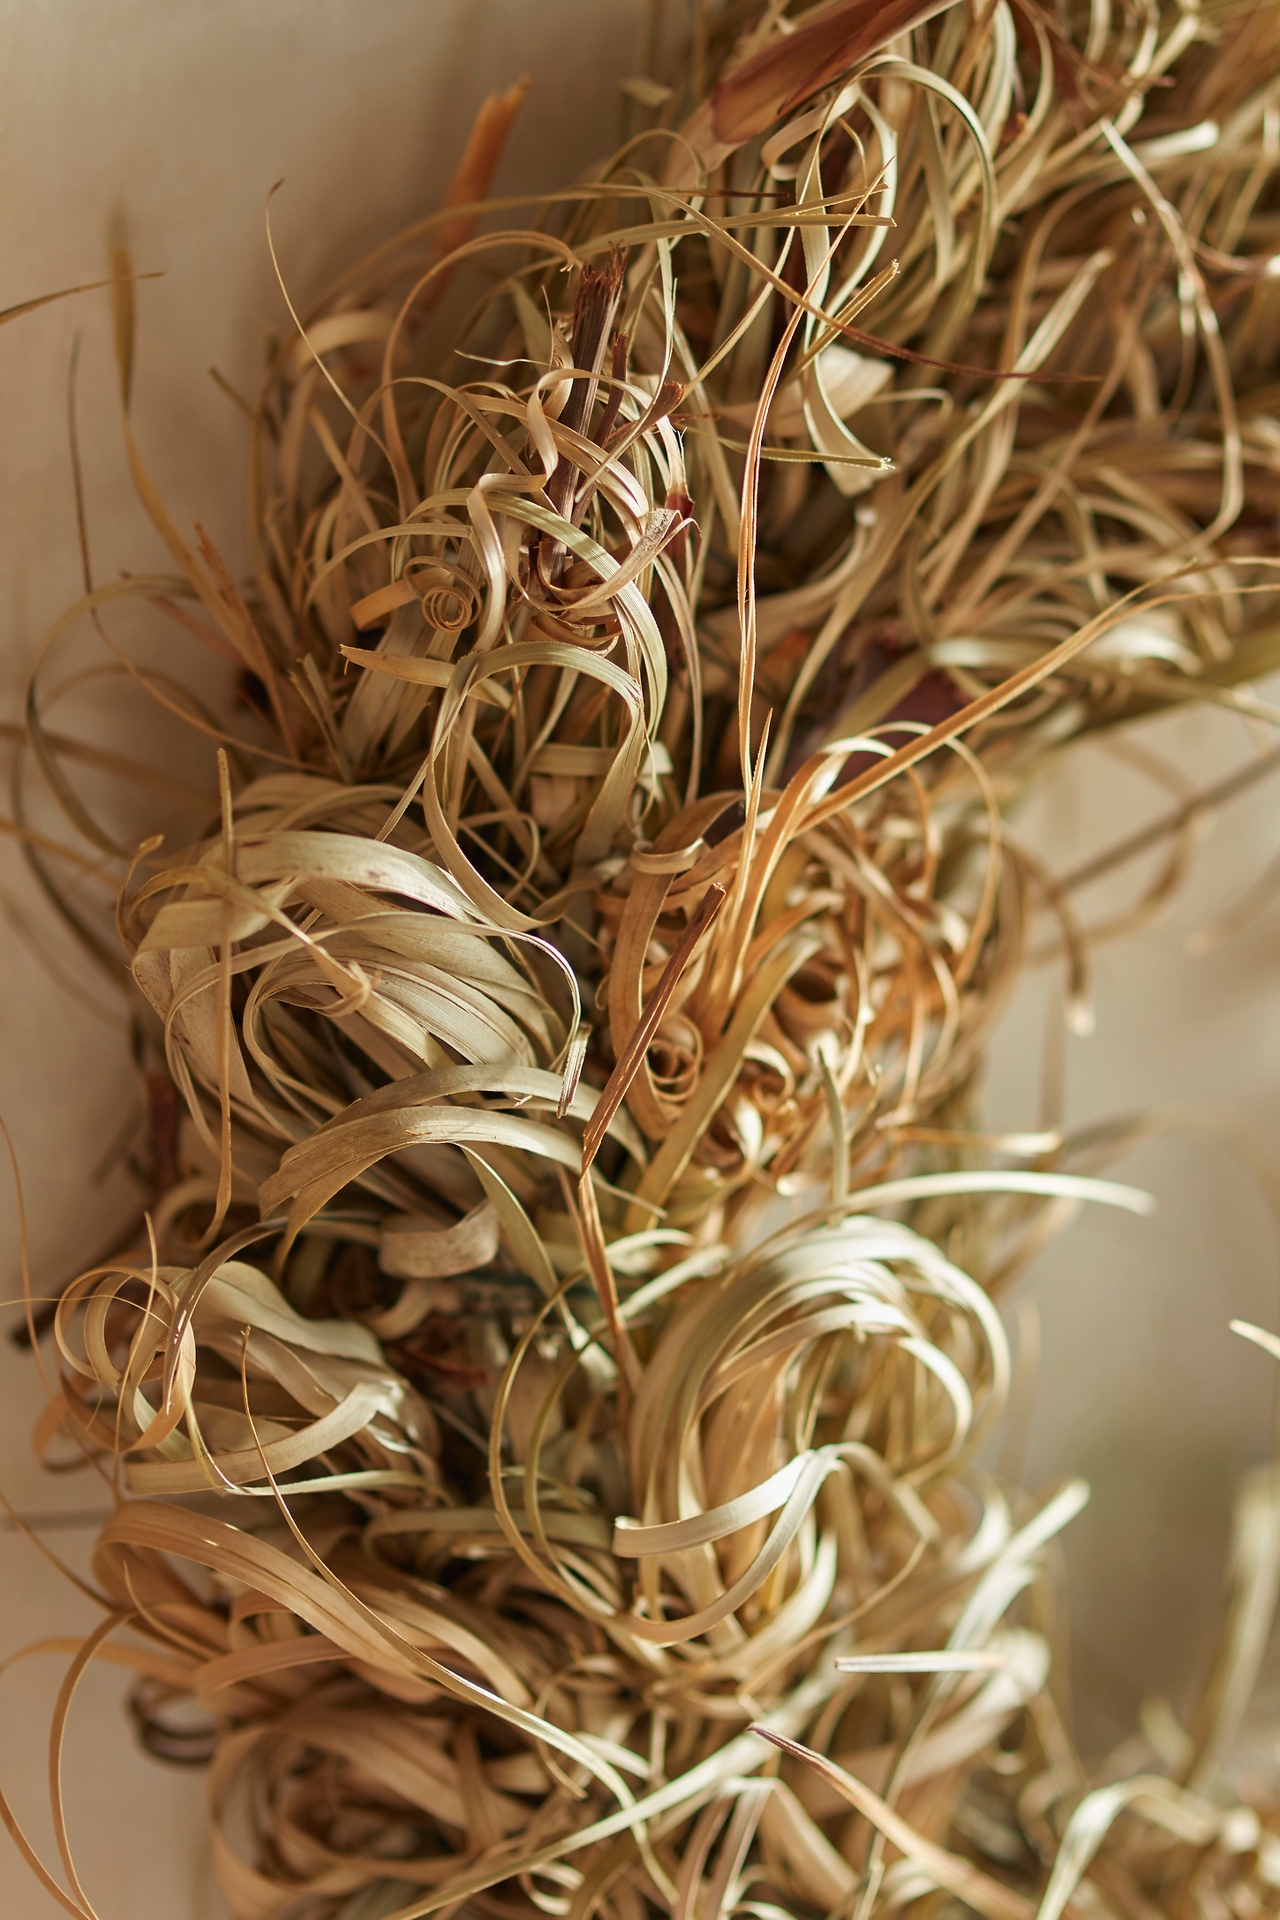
[988, 718, 1280, 1751]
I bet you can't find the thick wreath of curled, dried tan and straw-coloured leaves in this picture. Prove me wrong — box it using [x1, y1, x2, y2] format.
[10, 0, 1280, 1920]
